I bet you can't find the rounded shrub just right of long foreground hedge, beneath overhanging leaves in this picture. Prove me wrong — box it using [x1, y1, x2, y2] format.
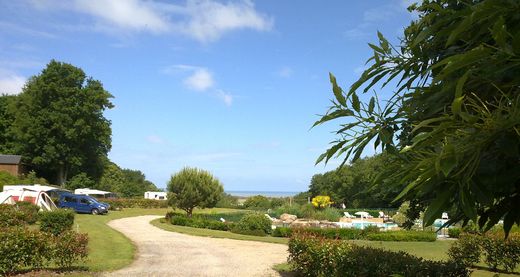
[448, 234, 481, 267]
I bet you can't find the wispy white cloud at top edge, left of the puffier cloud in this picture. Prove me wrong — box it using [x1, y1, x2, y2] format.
[75, 0, 169, 33]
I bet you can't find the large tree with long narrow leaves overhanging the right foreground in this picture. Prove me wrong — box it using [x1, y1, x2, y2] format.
[316, 0, 520, 233]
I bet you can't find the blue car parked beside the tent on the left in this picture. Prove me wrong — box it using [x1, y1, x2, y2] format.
[58, 194, 110, 214]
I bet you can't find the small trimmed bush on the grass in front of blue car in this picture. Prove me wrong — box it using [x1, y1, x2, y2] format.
[40, 209, 76, 236]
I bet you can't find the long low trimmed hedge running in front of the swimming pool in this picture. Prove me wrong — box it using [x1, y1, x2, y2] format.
[273, 227, 437, 241]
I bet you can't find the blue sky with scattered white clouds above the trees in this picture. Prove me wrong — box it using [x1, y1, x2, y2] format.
[0, 0, 414, 191]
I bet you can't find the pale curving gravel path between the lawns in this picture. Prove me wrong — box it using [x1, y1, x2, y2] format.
[101, 216, 287, 276]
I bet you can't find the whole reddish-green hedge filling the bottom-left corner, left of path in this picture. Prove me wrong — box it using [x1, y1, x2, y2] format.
[0, 227, 88, 275]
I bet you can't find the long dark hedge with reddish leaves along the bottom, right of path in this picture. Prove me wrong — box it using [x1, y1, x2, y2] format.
[289, 232, 469, 276]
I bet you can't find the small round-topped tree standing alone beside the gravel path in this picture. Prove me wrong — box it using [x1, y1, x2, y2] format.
[168, 167, 224, 217]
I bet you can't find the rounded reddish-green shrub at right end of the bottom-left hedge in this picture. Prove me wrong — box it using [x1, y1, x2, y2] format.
[52, 231, 88, 268]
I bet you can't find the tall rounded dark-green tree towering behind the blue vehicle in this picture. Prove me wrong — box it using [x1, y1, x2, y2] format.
[9, 60, 112, 185]
